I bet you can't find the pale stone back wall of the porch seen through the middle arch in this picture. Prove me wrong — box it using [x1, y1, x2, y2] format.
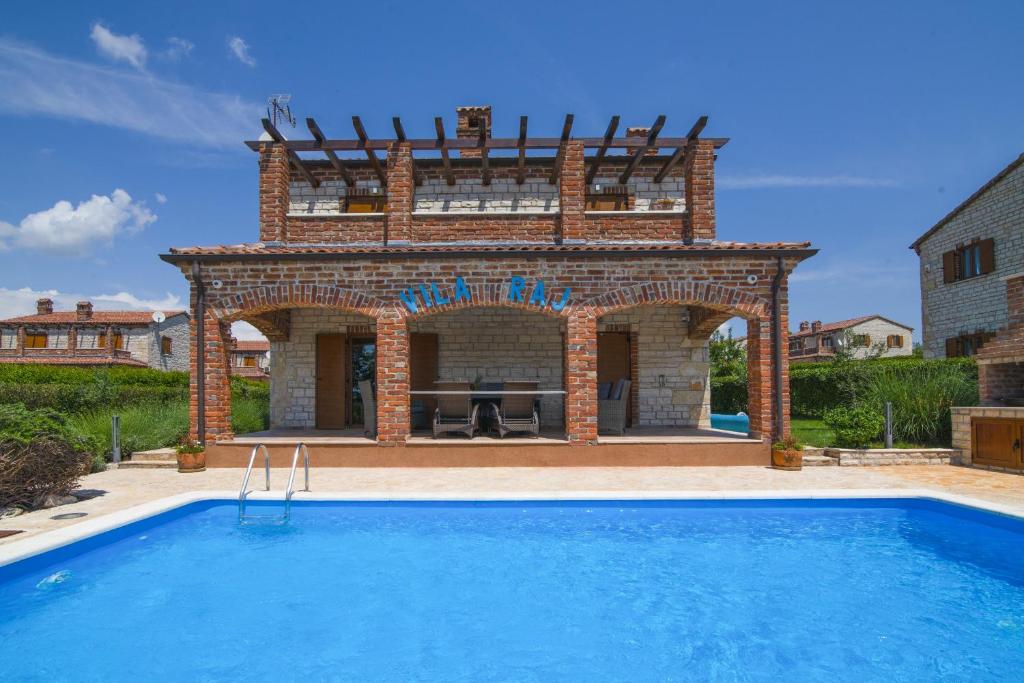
[410, 308, 565, 427]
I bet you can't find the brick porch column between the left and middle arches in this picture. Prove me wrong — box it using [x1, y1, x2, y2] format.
[377, 310, 411, 445]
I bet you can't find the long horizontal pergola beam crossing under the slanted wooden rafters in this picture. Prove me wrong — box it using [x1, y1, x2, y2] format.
[245, 137, 729, 152]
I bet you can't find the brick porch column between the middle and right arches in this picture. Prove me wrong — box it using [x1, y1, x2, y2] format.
[565, 310, 597, 445]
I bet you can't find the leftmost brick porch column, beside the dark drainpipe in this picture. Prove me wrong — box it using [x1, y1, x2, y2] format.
[188, 305, 233, 443]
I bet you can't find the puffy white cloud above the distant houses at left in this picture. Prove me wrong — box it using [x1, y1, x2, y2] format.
[0, 189, 157, 254]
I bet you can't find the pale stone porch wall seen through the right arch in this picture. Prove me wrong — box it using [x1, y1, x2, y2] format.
[597, 305, 711, 427]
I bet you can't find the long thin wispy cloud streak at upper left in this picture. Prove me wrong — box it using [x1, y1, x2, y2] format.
[0, 38, 263, 151]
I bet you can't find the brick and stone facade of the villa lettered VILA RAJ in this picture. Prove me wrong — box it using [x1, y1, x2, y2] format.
[163, 109, 814, 454]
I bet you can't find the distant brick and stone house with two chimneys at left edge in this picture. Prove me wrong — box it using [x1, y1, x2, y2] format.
[0, 299, 188, 371]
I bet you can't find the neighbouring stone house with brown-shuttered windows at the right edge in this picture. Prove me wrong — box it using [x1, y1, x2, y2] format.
[911, 155, 1024, 358]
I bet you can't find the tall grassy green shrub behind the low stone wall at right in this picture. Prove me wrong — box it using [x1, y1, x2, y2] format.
[860, 362, 978, 445]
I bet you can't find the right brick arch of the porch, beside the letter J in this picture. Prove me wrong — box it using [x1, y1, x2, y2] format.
[580, 281, 771, 321]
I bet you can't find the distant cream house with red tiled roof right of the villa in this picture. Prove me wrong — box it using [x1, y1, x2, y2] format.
[790, 315, 913, 362]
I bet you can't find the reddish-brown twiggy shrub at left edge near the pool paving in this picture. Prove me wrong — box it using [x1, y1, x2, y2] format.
[0, 437, 89, 508]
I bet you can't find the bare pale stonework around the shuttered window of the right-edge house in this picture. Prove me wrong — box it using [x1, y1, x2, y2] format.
[920, 159, 1024, 358]
